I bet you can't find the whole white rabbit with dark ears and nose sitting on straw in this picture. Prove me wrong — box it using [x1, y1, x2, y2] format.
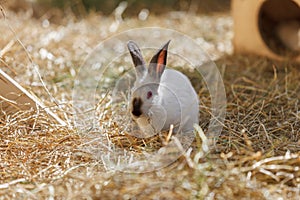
[127, 41, 199, 136]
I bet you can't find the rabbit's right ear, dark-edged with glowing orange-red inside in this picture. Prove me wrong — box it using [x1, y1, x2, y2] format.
[148, 40, 170, 79]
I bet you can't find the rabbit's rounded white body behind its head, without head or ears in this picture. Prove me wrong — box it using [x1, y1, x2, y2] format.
[149, 69, 199, 132]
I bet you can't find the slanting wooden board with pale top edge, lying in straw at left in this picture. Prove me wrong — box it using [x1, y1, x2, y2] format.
[0, 69, 67, 126]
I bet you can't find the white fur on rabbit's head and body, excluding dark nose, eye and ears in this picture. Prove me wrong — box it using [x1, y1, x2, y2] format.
[128, 42, 199, 135]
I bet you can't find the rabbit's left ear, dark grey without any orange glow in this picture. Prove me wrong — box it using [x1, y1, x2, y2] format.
[127, 41, 147, 77]
